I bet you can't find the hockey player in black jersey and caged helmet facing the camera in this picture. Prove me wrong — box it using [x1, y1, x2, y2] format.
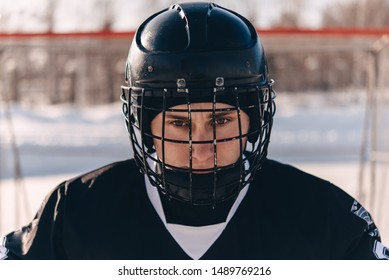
[0, 3, 389, 259]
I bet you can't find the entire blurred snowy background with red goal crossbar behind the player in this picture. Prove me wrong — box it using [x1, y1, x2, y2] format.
[0, 0, 389, 246]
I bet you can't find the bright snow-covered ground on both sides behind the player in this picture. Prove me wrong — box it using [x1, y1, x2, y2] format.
[0, 91, 389, 245]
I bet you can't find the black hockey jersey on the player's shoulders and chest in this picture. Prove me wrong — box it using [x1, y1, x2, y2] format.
[0, 160, 389, 260]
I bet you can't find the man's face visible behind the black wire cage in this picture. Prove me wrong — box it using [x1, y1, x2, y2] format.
[151, 103, 250, 172]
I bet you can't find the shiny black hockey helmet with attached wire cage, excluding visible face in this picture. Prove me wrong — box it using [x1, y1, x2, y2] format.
[121, 2, 275, 205]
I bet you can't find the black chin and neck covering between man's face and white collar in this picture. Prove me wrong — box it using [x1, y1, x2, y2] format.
[156, 161, 241, 226]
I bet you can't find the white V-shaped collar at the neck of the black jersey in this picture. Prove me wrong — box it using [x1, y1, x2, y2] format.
[145, 156, 249, 260]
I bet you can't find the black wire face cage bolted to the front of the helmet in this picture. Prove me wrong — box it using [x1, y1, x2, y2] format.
[121, 77, 276, 206]
